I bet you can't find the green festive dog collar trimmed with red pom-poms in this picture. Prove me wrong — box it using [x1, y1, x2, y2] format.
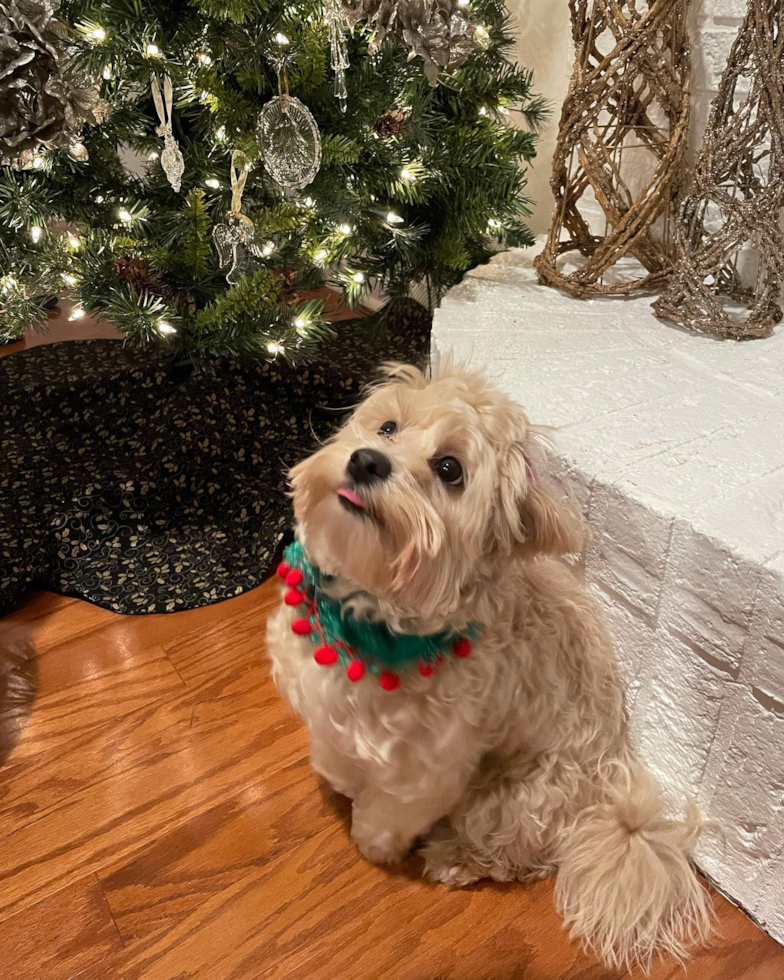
[278, 541, 480, 690]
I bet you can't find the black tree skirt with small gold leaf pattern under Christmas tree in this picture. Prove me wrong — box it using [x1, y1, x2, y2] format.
[0, 304, 430, 614]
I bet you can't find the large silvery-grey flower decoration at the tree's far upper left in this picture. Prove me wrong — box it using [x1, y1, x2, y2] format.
[0, 0, 108, 170]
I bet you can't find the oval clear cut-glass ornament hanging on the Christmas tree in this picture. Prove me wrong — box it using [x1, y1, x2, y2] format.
[256, 94, 321, 190]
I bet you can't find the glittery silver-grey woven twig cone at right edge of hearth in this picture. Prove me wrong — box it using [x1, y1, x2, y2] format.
[653, 0, 784, 338]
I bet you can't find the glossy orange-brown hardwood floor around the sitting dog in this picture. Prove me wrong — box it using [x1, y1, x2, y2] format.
[0, 582, 784, 980]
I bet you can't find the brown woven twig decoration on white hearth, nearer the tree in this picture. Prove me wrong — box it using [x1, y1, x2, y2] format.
[536, 0, 689, 297]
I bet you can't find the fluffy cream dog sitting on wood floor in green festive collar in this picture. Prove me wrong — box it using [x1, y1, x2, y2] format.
[267, 364, 712, 970]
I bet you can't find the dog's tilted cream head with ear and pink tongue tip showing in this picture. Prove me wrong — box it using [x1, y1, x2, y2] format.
[291, 365, 578, 616]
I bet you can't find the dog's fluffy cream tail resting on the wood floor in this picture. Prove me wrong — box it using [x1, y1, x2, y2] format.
[555, 763, 713, 972]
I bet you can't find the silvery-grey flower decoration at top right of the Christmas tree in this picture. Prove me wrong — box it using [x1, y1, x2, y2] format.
[343, 0, 476, 85]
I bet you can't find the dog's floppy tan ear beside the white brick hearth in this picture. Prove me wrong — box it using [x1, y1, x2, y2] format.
[499, 443, 584, 557]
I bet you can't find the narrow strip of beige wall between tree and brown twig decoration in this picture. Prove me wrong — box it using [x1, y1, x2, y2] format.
[507, 0, 574, 234]
